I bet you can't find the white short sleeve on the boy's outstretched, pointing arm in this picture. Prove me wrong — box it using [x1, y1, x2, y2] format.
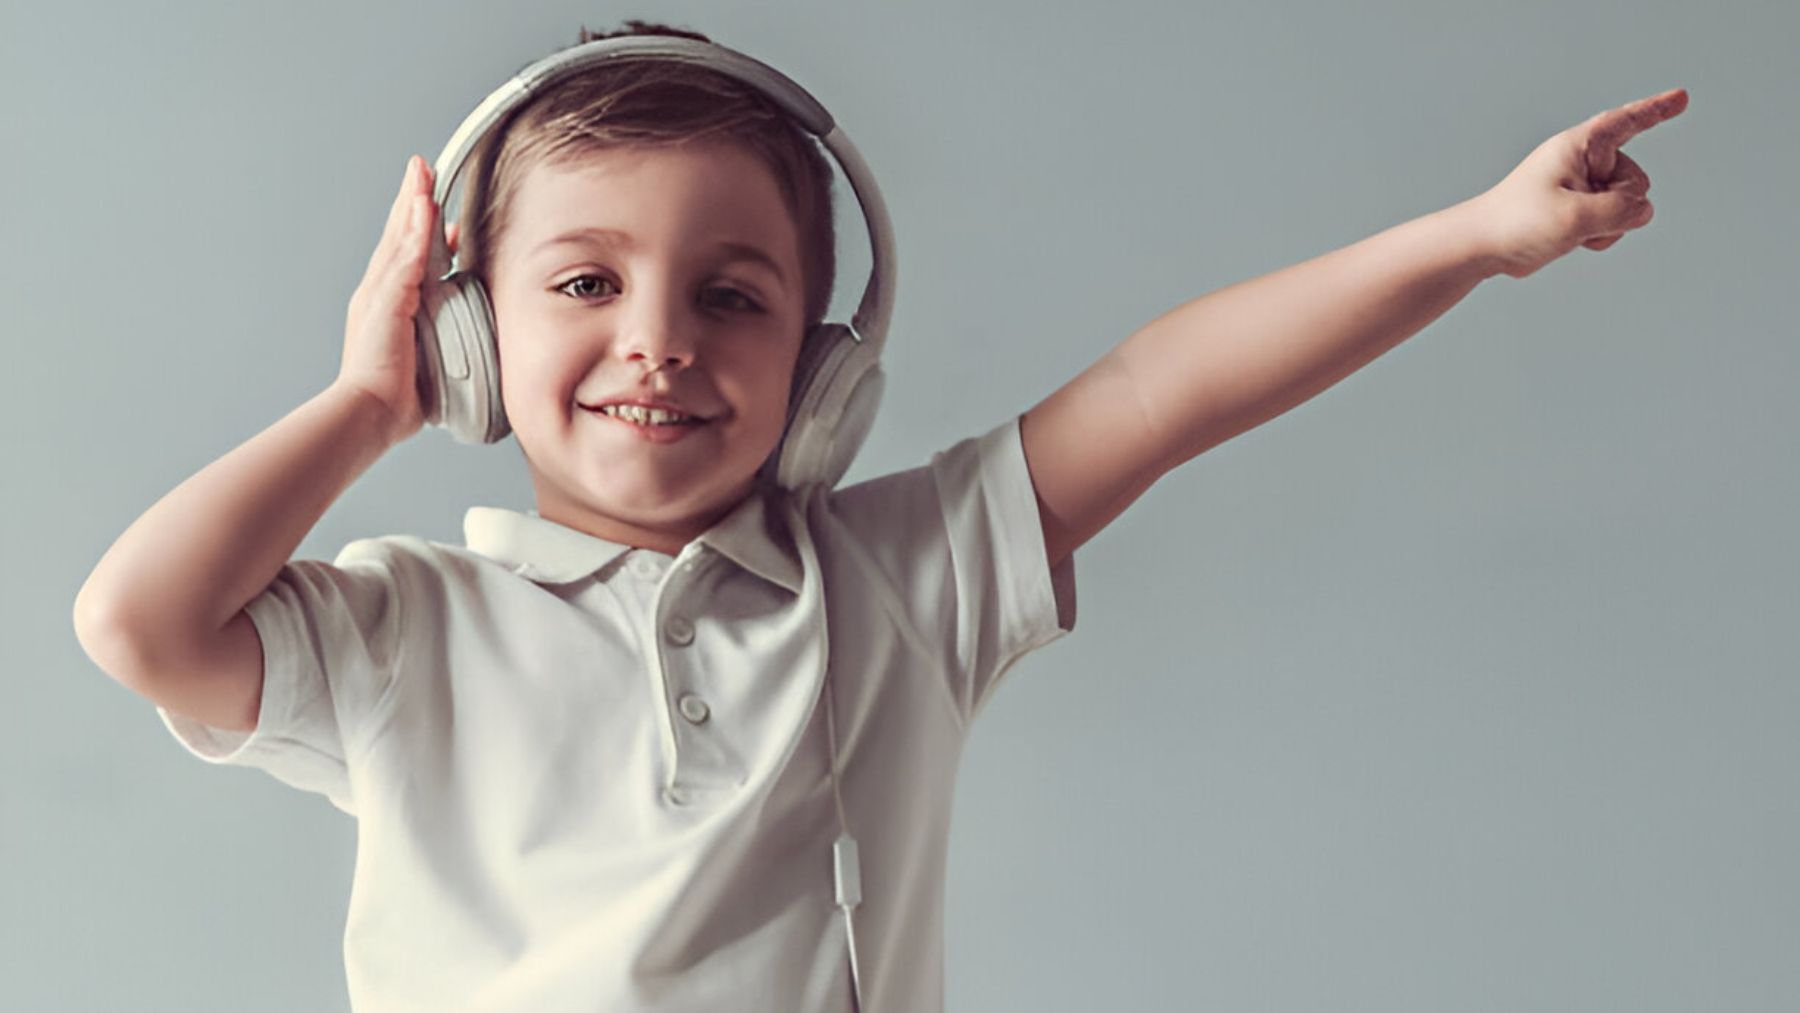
[832, 417, 1076, 722]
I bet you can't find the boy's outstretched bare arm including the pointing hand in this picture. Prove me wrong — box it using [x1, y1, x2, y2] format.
[1019, 88, 1687, 567]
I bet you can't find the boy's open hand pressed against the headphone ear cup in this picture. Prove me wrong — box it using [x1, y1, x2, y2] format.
[335, 155, 455, 443]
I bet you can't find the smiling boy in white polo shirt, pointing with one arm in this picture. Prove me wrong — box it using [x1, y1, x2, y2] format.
[76, 15, 1687, 1013]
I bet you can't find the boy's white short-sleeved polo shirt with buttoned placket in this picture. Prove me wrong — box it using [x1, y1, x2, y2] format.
[158, 417, 1075, 1013]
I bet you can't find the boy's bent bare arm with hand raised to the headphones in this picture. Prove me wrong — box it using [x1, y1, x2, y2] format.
[74, 158, 454, 731]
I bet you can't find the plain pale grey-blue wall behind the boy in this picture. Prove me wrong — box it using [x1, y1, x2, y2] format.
[0, 0, 1800, 1013]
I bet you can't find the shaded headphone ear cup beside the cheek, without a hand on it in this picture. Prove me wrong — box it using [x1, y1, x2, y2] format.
[772, 324, 886, 489]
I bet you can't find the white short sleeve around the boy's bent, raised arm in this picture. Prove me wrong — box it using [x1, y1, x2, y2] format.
[157, 540, 403, 815]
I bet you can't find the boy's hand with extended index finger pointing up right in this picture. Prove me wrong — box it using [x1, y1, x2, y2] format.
[1471, 88, 1688, 277]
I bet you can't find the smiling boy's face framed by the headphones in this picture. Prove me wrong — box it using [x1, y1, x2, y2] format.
[488, 142, 803, 556]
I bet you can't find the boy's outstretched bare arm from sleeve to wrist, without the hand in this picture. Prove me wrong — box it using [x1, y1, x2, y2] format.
[1019, 196, 1498, 567]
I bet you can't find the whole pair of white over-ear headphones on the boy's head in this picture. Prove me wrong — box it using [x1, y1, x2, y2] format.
[414, 36, 895, 489]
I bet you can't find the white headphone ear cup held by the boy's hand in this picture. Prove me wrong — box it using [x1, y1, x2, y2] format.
[414, 272, 511, 443]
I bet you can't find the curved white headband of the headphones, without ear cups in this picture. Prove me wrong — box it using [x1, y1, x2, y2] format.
[428, 36, 895, 358]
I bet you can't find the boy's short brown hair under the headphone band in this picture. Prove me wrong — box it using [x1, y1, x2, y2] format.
[457, 18, 837, 326]
